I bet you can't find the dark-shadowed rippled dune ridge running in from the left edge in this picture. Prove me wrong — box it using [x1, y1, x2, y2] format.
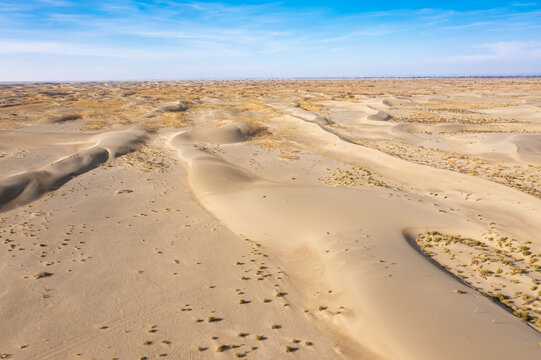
[0, 129, 148, 211]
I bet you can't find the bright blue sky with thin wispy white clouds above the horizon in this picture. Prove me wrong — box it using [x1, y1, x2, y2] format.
[0, 0, 541, 81]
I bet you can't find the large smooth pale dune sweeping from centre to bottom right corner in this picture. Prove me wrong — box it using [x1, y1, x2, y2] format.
[170, 124, 541, 359]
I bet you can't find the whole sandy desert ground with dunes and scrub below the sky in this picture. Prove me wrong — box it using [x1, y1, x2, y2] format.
[0, 79, 541, 360]
